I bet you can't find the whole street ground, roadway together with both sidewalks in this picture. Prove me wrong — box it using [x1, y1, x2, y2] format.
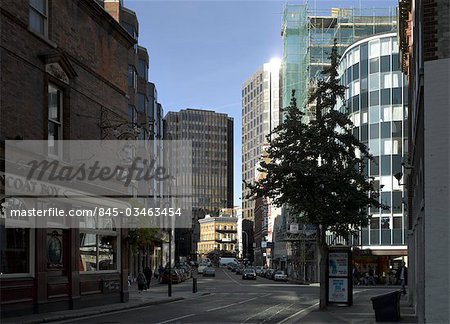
[1, 269, 417, 324]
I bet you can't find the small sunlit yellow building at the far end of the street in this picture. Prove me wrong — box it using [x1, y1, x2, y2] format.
[198, 215, 237, 255]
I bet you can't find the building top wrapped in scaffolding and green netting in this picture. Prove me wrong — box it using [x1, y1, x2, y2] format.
[281, 4, 397, 120]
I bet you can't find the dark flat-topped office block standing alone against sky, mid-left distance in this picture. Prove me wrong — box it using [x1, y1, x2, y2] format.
[164, 109, 233, 218]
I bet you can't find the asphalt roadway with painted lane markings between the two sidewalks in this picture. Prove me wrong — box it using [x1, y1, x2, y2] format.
[57, 269, 319, 324]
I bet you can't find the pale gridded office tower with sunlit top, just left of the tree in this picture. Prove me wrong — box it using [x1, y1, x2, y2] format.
[242, 59, 280, 221]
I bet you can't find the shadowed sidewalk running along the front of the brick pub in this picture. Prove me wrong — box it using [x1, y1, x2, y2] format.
[1, 280, 204, 324]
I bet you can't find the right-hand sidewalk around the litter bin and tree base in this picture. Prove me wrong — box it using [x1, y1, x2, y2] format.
[292, 286, 417, 324]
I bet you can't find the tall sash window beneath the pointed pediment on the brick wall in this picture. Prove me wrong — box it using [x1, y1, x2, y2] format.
[48, 84, 63, 155]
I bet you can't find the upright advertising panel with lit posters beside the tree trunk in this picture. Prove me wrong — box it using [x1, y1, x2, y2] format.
[326, 246, 353, 306]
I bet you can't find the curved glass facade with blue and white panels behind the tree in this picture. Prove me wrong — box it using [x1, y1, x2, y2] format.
[338, 33, 408, 246]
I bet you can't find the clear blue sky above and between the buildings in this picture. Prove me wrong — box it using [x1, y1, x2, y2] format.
[124, 0, 398, 205]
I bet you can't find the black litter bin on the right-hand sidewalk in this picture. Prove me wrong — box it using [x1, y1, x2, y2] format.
[371, 291, 402, 322]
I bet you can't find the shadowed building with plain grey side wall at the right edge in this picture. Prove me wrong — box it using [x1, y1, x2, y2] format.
[399, 0, 450, 323]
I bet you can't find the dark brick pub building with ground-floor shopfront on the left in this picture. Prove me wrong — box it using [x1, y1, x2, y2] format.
[0, 0, 142, 315]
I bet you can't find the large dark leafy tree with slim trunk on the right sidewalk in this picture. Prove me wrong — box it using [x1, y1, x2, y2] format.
[247, 44, 380, 309]
